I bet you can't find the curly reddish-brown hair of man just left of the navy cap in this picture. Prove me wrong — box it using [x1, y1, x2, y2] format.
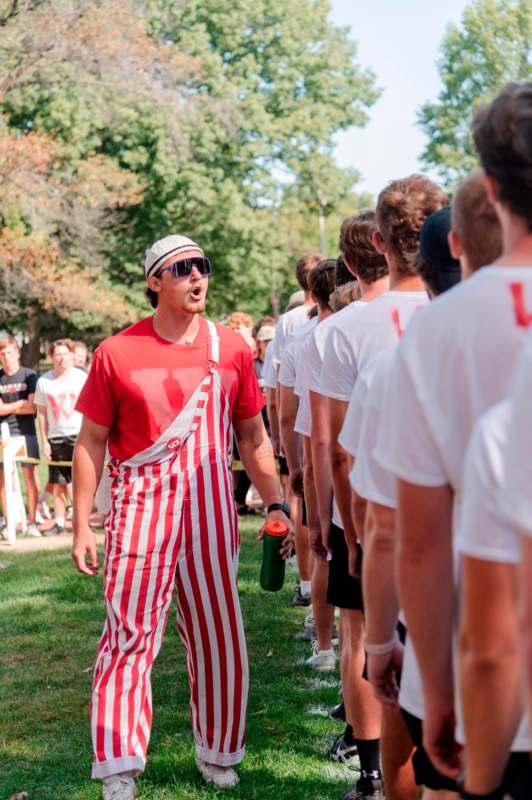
[376, 175, 449, 275]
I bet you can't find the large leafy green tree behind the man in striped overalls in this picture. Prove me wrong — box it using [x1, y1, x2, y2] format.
[0, 0, 378, 342]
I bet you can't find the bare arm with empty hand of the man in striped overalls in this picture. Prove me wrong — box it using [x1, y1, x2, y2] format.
[72, 417, 110, 576]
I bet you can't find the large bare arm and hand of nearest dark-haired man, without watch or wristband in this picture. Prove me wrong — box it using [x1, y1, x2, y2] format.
[397, 480, 460, 777]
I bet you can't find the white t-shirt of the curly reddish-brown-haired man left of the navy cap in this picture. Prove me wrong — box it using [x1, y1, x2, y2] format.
[319, 291, 428, 403]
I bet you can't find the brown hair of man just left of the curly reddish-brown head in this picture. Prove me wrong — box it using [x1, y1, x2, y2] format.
[338, 211, 388, 283]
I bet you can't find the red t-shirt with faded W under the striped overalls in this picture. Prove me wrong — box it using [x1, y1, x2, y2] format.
[76, 317, 264, 461]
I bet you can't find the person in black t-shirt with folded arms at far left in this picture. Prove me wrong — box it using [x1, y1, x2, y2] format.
[0, 334, 41, 536]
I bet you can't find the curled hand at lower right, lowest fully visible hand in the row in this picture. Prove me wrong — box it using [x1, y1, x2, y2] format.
[423, 703, 462, 778]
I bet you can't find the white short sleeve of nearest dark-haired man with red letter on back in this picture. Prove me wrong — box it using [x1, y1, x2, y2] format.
[375, 344, 449, 487]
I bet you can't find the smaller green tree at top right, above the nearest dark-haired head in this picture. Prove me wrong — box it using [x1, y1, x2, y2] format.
[418, 0, 532, 187]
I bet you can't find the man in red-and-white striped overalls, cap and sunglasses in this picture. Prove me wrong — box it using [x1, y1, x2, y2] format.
[73, 236, 291, 800]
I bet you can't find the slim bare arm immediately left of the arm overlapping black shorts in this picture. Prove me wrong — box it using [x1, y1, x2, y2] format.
[309, 391, 333, 555]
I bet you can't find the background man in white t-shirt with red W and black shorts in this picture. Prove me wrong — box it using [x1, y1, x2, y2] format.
[35, 339, 87, 536]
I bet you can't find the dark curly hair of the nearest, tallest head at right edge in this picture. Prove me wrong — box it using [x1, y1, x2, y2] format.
[473, 81, 532, 232]
